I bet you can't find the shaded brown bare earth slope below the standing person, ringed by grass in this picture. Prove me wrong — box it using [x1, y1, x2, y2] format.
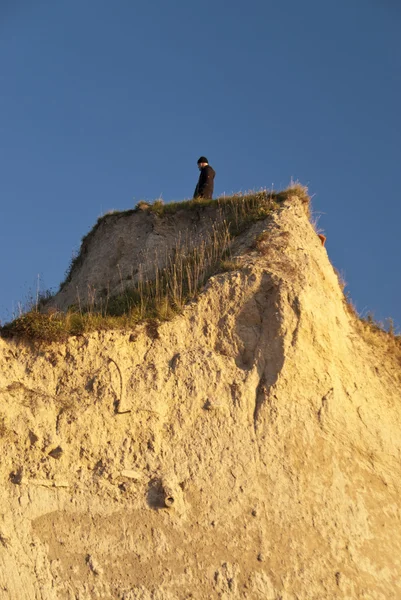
[51, 206, 230, 311]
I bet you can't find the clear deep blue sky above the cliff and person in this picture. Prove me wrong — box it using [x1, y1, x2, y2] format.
[0, 0, 401, 328]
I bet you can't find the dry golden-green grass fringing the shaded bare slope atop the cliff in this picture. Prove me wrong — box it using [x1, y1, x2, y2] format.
[0, 185, 309, 342]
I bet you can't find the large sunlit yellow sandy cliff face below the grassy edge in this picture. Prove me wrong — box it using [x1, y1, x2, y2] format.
[0, 198, 401, 600]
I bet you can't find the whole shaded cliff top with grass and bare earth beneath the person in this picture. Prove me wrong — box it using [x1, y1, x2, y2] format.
[2, 185, 309, 341]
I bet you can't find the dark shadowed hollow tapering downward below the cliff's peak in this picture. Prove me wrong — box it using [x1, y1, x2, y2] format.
[236, 273, 284, 430]
